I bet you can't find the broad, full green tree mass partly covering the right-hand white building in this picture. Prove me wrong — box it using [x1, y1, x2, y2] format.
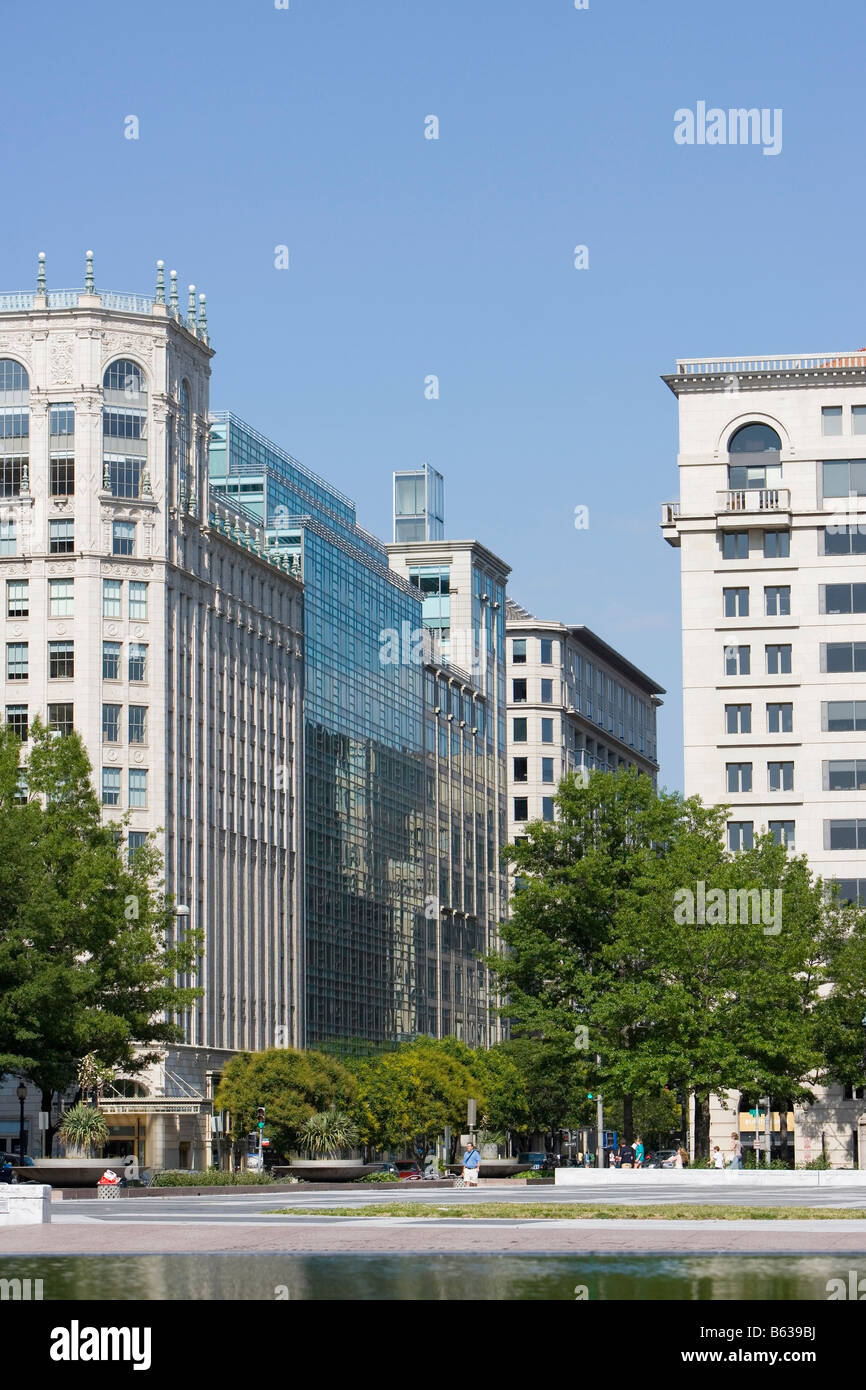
[493, 770, 827, 1156]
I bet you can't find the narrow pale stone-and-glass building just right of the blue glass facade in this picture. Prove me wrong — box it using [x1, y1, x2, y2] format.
[388, 511, 510, 1045]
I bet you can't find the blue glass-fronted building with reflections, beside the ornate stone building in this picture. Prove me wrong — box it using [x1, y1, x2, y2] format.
[210, 414, 428, 1049]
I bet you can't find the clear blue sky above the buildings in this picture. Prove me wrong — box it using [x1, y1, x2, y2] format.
[0, 0, 866, 785]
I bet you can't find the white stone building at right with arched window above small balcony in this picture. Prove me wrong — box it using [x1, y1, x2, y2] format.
[662, 344, 866, 1163]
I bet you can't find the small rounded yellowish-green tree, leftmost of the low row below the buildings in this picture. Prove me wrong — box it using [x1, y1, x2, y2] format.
[214, 1048, 356, 1155]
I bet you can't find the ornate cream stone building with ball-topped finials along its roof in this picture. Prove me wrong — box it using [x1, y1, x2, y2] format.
[0, 253, 304, 1168]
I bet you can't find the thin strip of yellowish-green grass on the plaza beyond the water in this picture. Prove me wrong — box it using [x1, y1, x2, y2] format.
[267, 1202, 866, 1220]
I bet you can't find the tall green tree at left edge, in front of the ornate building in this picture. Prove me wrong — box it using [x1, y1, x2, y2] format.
[0, 723, 202, 1151]
